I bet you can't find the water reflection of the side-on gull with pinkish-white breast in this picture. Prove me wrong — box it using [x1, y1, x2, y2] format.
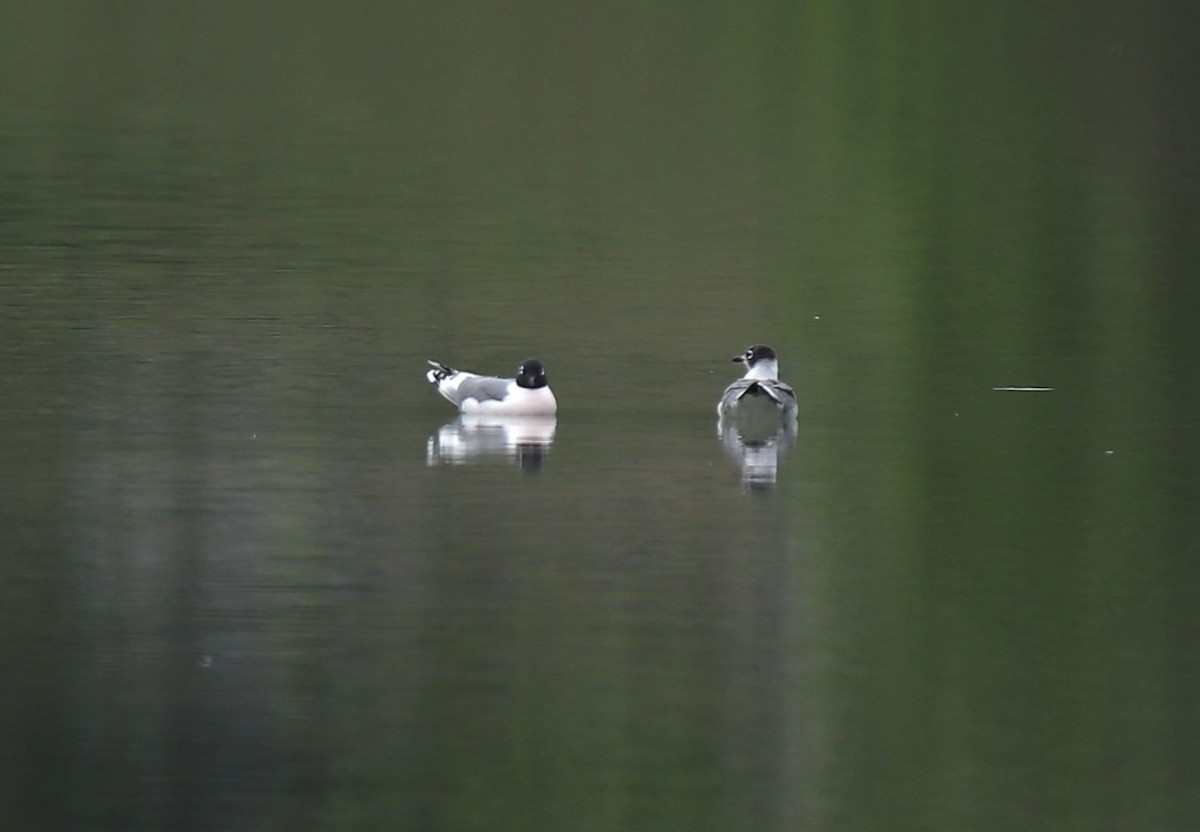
[425, 414, 558, 472]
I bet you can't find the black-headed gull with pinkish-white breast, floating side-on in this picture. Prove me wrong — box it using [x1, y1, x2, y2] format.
[425, 358, 558, 415]
